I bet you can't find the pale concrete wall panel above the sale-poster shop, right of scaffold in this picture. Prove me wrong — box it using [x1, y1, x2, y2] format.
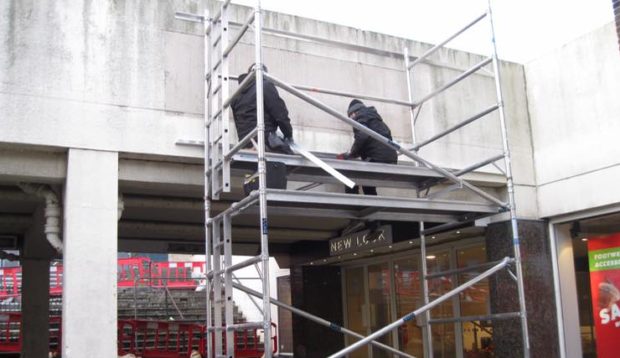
[526, 23, 620, 217]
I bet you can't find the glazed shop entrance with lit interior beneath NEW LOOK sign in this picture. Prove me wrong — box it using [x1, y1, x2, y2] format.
[342, 237, 494, 358]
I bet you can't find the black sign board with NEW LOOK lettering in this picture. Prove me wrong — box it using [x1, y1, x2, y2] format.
[329, 225, 392, 256]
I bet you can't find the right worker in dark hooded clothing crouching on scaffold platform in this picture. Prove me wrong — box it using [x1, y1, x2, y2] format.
[338, 99, 398, 195]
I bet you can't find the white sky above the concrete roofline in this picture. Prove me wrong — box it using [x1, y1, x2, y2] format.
[233, 0, 614, 63]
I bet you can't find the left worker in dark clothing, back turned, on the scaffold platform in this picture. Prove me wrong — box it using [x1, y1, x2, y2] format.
[230, 66, 293, 154]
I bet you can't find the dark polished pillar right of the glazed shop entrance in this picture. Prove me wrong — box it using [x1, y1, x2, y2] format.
[486, 220, 559, 358]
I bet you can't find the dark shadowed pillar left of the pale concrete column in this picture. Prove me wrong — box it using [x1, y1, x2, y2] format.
[21, 208, 54, 358]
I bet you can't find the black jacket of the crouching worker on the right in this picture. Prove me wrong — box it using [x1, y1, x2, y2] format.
[349, 107, 398, 163]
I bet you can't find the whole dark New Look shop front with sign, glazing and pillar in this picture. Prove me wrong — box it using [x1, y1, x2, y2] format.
[291, 220, 559, 358]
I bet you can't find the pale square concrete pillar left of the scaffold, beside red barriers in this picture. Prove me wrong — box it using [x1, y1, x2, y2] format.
[62, 149, 118, 358]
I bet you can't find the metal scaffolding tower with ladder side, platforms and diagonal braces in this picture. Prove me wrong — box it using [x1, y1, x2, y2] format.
[176, 0, 530, 358]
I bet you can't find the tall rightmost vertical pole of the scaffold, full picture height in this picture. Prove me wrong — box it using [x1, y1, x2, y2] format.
[487, 0, 530, 358]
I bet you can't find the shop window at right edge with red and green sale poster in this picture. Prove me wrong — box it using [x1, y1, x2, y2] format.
[550, 208, 620, 358]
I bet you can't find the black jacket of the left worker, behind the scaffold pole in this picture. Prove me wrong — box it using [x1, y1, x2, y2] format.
[230, 74, 293, 140]
